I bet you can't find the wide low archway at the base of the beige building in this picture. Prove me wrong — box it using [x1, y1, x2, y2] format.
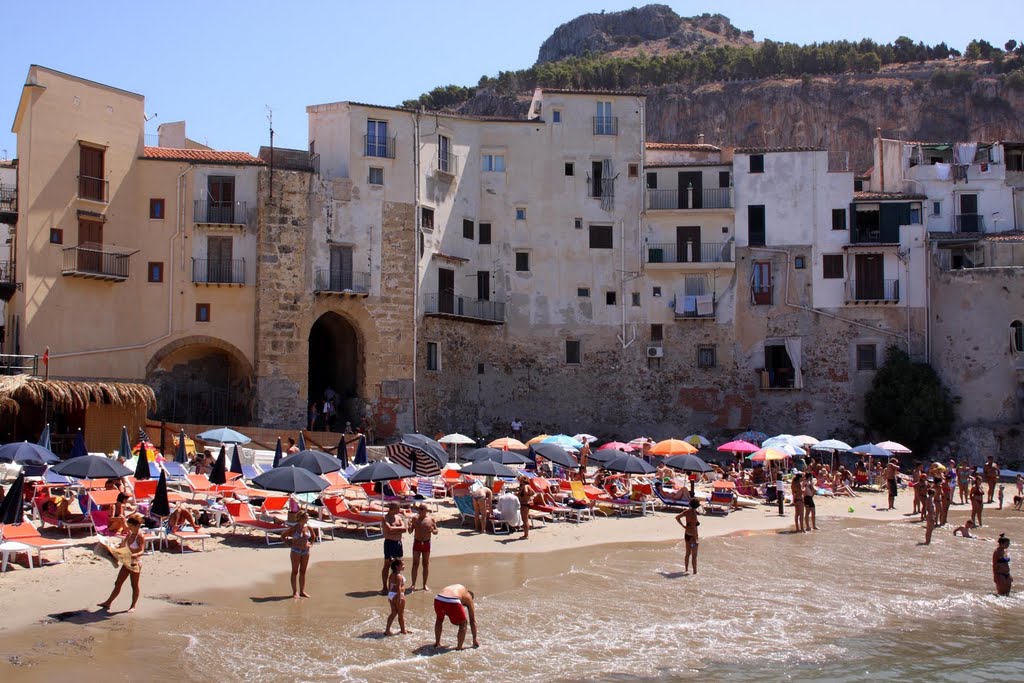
[145, 336, 253, 425]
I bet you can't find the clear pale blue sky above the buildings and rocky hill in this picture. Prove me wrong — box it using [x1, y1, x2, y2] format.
[0, 0, 1024, 158]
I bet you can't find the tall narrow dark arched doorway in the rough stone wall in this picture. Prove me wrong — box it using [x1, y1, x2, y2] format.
[307, 313, 362, 431]
